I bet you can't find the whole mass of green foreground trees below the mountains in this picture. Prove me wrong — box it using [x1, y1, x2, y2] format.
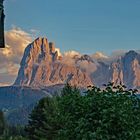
[26, 83, 140, 140]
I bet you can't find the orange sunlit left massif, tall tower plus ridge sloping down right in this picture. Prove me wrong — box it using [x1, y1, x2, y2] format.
[14, 38, 92, 87]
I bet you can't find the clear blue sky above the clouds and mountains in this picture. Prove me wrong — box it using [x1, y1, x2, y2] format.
[4, 0, 140, 54]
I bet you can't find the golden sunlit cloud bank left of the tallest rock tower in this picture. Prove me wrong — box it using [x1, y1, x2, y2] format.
[0, 26, 32, 85]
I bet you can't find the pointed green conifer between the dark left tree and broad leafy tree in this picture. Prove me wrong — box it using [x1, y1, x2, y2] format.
[57, 84, 85, 140]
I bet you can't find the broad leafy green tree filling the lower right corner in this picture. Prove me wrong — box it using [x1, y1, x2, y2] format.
[71, 83, 140, 140]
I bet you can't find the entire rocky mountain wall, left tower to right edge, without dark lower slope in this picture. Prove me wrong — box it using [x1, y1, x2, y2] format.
[14, 38, 140, 89]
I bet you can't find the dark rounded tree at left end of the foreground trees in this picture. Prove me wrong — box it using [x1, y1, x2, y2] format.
[26, 97, 60, 140]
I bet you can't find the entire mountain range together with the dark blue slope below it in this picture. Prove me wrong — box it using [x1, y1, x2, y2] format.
[0, 38, 140, 124]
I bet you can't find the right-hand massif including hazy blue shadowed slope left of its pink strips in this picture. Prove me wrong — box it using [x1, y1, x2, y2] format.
[91, 51, 140, 90]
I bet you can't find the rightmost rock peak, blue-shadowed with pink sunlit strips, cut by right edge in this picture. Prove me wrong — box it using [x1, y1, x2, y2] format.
[100, 51, 140, 89]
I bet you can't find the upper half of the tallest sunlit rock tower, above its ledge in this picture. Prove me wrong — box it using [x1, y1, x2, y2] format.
[21, 37, 58, 64]
